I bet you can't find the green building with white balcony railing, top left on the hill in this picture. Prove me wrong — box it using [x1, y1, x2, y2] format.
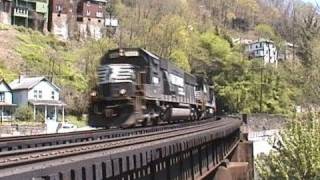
[12, 0, 49, 31]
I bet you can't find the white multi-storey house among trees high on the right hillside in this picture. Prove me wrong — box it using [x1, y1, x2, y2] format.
[246, 39, 278, 64]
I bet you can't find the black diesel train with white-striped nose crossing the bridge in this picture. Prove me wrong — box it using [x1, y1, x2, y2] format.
[89, 48, 216, 128]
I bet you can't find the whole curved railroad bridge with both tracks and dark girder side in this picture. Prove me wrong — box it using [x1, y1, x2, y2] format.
[0, 117, 253, 180]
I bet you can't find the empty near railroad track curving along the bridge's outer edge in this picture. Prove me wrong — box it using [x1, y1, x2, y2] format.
[0, 120, 239, 169]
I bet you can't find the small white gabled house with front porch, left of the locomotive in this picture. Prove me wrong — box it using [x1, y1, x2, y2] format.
[10, 76, 65, 122]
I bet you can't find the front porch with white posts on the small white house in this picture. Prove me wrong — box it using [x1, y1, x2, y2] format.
[29, 100, 66, 122]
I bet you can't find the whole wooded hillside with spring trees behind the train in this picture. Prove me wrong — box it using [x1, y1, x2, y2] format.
[0, 0, 320, 115]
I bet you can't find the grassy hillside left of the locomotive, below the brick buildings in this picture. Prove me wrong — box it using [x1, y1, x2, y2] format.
[0, 25, 112, 115]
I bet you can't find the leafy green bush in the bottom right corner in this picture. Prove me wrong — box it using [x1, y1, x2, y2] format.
[256, 114, 320, 180]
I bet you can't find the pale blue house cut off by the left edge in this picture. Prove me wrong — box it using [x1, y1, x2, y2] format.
[0, 79, 16, 122]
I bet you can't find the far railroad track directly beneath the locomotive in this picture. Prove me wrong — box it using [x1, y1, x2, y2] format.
[0, 117, 228, 153]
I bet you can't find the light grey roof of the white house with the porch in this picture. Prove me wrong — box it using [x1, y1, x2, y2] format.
[10, 76, 60, 91]
